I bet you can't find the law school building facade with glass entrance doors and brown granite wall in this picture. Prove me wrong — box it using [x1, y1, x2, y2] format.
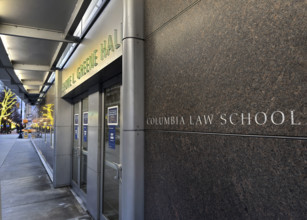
[24, 0, 307, 220]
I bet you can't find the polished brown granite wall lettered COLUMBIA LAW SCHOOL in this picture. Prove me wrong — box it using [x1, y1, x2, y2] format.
[145, 0, 307, 219]
